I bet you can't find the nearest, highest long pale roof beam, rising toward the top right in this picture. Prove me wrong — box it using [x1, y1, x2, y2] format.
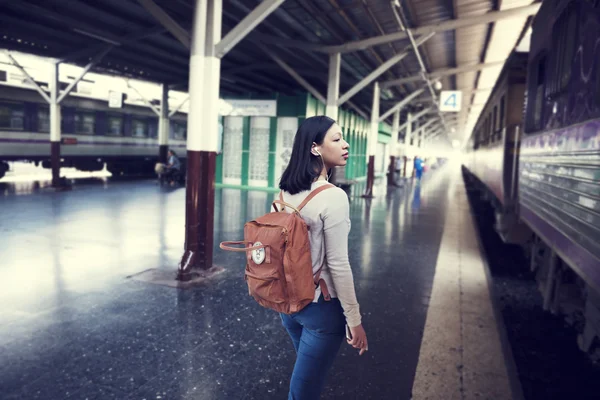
[327, 3, 541, 53]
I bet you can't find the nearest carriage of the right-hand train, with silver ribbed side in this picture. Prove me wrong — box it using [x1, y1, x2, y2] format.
[518, 0, 600, 351]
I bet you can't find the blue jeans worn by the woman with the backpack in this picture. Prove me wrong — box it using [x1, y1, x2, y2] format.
[280, 295, 346, 400]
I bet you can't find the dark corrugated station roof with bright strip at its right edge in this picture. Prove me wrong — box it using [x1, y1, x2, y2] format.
[0, 0, 539, 139]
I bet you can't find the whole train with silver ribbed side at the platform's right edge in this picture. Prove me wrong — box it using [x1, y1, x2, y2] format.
[463, 0, 600, 361]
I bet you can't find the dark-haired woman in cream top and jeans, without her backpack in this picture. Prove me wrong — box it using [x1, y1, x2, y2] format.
[279, 116, 368, 400]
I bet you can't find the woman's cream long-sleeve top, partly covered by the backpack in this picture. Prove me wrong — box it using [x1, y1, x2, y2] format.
[277, 180, 361, 327]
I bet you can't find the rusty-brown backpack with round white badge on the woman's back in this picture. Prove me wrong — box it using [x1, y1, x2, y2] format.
[220, 184, 333, 314]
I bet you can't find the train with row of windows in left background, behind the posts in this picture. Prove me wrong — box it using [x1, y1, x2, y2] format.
[0, 65, 187, 179]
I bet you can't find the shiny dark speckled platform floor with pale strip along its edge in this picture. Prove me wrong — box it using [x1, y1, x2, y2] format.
[0, 161, 511, 400]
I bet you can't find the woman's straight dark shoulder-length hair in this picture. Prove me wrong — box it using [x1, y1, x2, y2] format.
[279, 115, 335, 194]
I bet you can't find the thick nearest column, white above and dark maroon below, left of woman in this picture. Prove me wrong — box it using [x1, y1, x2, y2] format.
[177, 0, 222, 281]
